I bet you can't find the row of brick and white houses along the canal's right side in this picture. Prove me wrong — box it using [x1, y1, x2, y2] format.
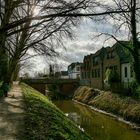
[68, 41, 134, 88]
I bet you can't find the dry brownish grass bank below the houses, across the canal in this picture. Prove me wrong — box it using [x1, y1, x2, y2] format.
[73, 86, 140, 125]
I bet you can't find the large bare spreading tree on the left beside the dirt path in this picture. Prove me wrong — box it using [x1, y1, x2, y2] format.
[0, 0, 93, 81]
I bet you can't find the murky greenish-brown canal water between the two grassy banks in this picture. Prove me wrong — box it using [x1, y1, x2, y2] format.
[53, 100, 140, 140]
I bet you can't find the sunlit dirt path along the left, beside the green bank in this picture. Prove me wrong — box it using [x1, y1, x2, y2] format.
[0, 83, 25, 140]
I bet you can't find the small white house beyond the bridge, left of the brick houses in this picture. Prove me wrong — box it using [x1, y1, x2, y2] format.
[68, 62, 82, 79]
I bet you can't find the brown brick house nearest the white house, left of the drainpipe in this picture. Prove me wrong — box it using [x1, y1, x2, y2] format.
[81, 48, 105, 88]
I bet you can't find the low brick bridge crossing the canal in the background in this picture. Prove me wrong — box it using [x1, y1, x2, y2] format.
[21, 78, 79, 96]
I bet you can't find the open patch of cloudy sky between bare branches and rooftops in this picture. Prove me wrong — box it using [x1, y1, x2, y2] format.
[22, 16, 128, 75]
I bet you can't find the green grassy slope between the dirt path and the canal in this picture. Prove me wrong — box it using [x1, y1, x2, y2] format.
[21, 84, 91, 140]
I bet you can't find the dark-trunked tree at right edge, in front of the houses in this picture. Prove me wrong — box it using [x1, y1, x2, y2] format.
[96, 0, 140, 84]
